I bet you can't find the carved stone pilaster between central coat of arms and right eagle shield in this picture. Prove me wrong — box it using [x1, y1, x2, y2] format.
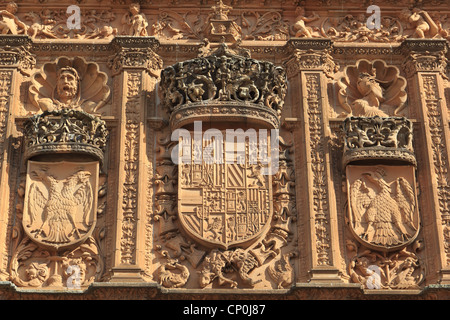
[285, 39, 341, 282]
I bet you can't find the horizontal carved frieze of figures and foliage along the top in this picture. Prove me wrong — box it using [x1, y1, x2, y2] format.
[1, 0, 448, 43]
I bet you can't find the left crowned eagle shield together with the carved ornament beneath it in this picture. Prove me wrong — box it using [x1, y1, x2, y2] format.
[9, 109, 108, 289]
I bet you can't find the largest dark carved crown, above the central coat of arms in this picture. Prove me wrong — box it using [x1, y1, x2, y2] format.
[159, 43, 287, 128]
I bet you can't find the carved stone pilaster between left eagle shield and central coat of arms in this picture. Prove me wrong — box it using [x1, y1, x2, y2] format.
[106, 37, 162, 282]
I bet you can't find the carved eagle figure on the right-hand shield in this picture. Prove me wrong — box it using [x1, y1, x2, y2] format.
[350, 168, 418, 248]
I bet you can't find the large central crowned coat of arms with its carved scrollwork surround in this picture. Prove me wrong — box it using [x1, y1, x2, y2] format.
[153, 38, 297, 288]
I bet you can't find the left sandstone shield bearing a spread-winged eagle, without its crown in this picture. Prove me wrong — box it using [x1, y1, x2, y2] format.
[22, 161, 99, 250]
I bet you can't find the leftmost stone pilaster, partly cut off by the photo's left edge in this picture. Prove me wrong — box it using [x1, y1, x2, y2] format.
[0, 35, 36, 279]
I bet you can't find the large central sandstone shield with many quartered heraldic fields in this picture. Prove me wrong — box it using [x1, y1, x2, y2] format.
[178, 131, 272, 249]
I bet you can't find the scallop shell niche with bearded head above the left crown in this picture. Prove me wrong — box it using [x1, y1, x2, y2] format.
[29, 57, 110, 113]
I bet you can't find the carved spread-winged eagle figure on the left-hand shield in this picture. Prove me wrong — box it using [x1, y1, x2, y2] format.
[27, 170, 93, 246]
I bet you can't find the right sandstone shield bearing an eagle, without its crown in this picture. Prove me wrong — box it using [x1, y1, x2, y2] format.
[347, 165, 420, 251]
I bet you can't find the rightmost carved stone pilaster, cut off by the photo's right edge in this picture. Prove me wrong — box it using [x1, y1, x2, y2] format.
[402, 39, 450, 284]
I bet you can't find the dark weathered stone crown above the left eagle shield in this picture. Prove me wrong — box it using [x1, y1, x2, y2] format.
[24, 109, 108, 163]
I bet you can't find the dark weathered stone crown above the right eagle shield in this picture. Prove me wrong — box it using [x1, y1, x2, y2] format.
[342, 116, 416, 166]
